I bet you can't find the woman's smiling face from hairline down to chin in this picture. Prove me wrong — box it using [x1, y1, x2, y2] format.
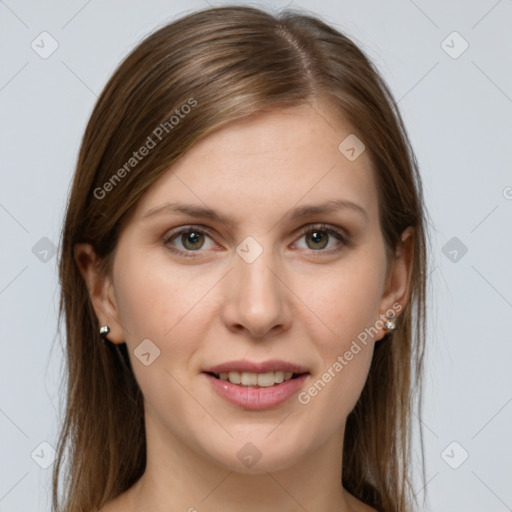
[84, 104, 407, 472]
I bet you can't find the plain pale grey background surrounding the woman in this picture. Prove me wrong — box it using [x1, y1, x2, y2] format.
[0, 0, 512, 512]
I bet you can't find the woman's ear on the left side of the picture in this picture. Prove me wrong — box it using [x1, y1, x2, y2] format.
[74, 243, 124, 343]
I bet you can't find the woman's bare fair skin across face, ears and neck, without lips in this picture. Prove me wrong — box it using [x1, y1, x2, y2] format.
[81, 100, 412, 512]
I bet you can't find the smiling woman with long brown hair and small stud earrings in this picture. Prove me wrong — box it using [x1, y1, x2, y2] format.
[53, 6, 426, 512]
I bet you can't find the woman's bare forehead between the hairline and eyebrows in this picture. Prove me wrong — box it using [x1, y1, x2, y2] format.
[132, 104, 377, 224]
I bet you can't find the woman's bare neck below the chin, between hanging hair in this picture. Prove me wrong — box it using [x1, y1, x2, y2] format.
[126, 406, 353, 512]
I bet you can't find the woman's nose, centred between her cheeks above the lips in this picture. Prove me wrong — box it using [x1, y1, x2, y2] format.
[222, 244, 292, 338]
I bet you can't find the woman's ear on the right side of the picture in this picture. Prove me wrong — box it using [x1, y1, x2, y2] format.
[375, 226, 414, 341]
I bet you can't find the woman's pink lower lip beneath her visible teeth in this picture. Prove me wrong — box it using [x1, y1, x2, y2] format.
[204, 373, 309, 411]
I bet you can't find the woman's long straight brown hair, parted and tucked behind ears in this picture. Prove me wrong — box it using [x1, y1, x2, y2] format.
[52, 6, 427, 512]
